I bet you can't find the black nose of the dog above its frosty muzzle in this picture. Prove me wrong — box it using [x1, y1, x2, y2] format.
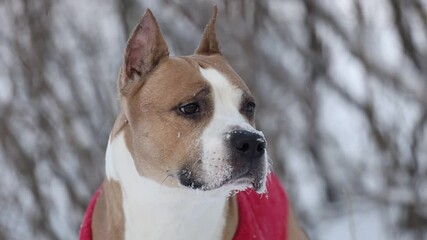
[230, 131, 266, 159]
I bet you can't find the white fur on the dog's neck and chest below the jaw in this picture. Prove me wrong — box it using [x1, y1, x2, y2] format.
[106, 122, 237, 239]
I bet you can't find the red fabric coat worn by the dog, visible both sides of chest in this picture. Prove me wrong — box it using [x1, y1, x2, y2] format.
[80, 174, 289, 240]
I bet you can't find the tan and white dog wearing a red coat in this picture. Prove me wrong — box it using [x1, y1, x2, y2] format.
[80, 6, 306, 240]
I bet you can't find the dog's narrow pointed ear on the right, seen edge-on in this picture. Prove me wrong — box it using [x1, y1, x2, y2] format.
[194, 5, 221, 55]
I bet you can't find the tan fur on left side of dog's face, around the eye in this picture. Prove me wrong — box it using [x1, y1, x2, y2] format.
[122, 58, 213, 185]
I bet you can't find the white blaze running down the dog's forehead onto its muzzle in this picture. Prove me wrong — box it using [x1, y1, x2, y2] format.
[200, 68, 262, 187]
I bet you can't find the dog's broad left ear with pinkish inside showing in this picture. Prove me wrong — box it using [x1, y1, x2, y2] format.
[118, 9, 169, 95]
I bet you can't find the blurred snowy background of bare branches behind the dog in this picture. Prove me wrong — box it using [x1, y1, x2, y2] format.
[0, 0, 427, 240]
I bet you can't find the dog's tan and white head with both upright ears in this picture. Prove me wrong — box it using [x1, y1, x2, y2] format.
[118, 9, 267, 192]
